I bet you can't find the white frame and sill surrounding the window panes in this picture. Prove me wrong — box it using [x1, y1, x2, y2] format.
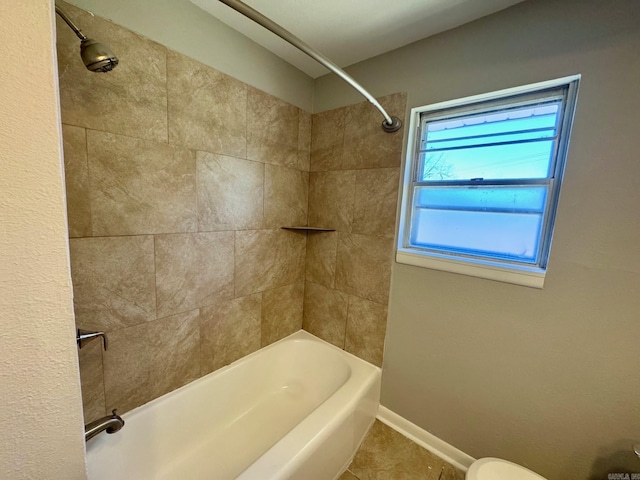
[396, 75, 581, 288]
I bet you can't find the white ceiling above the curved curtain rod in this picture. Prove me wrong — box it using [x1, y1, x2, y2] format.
[191, 0, 523, 78]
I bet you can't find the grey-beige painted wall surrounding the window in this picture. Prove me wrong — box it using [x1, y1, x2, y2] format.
[315, 0, 640, 479]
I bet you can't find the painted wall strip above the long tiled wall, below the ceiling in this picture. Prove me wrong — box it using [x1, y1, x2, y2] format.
[63, 0, 313, 111]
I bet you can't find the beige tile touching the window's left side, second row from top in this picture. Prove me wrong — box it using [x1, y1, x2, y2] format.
[351, 168, 400, 238]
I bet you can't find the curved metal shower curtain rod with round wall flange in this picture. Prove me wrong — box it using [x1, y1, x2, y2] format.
[219, 0, 402, 133]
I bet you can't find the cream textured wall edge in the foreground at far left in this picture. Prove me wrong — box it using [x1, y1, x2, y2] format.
[0, 1, 86, 480]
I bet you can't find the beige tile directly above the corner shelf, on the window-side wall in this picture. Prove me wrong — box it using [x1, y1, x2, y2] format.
[309, 171, 356, 232]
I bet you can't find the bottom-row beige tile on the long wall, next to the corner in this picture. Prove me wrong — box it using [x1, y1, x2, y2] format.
[261, 282, 304, 347]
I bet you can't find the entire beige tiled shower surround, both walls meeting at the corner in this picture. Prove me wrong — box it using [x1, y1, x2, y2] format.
[58, 4, 406, 421]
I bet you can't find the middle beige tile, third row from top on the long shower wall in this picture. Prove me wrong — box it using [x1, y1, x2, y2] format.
[155, 232, 234, 317]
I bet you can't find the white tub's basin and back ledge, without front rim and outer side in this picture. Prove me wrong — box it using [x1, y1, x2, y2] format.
[87, 332, 375, 480]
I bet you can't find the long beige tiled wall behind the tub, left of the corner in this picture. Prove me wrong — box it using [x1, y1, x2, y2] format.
[58, 0, 311, 420]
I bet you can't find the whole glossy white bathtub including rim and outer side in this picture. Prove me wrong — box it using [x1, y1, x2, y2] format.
[87, 330, 380, 480]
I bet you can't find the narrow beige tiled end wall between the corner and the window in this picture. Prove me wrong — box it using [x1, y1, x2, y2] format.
[304, 94, 406, 365]
